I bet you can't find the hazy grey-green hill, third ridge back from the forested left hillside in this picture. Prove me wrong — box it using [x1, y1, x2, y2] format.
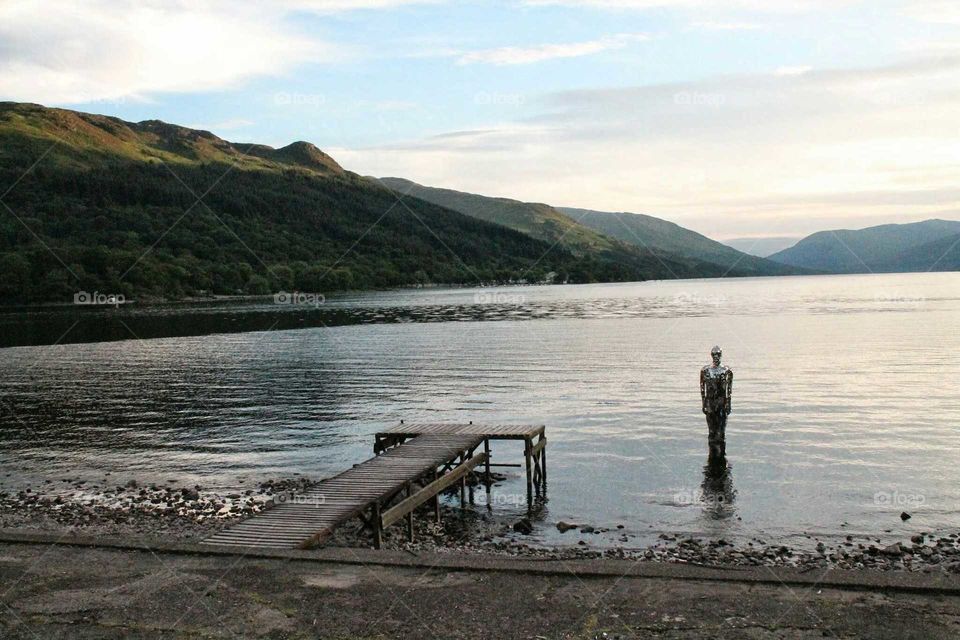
[559, 207, 804, 276]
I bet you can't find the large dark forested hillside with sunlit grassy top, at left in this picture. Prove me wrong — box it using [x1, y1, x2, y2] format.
[0, 103, 632, 303]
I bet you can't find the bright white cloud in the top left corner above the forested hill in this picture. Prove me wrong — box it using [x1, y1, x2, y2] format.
[0, 0, 430, 104]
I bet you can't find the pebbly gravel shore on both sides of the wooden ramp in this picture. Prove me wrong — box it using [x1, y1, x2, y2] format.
[0, 478, 960, 574]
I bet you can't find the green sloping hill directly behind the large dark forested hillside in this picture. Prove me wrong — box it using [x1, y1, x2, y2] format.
[377, 178, 789, 279]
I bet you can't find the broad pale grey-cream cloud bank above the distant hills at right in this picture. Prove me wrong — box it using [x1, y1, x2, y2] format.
[334, 57, 960, 237]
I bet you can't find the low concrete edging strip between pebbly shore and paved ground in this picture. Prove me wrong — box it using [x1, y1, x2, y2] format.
[0, 530, 960, 595]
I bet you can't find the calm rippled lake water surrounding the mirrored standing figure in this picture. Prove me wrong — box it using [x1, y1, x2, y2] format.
[0, 273, 960, 544]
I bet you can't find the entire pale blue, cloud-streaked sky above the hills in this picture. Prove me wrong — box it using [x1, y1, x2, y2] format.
[0, 0, 960, 240]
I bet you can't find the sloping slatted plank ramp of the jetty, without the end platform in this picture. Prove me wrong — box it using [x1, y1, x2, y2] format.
[203, 433, 486, 548]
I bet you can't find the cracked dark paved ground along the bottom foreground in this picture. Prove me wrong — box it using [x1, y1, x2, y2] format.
[0, 543, 960, 640]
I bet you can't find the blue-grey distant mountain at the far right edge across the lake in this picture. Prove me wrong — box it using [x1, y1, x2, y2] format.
[770, 220, 960, 273]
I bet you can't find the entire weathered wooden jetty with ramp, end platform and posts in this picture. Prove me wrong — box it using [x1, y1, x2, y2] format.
[203, 422, 547, 548]
